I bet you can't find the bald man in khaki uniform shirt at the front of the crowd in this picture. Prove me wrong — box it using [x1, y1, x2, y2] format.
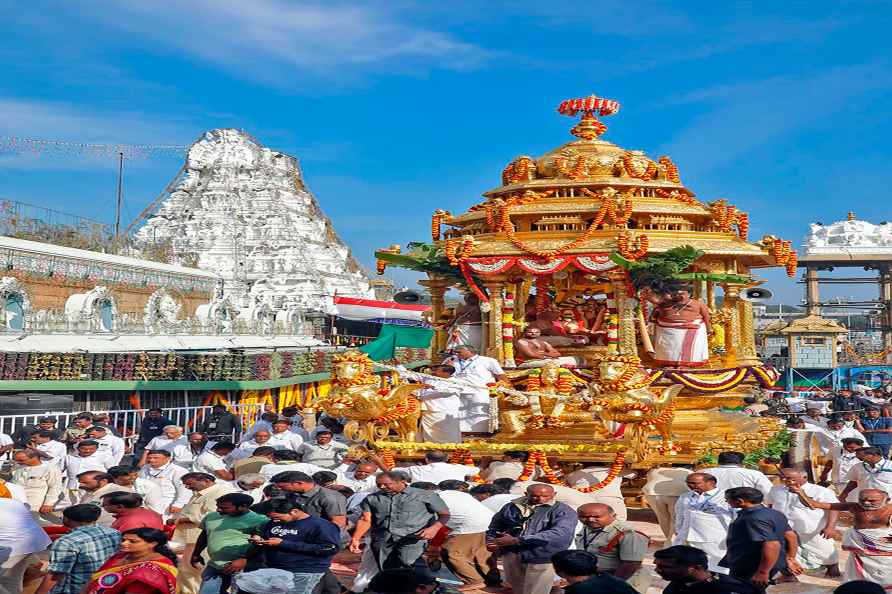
[576, 503, 652, 594]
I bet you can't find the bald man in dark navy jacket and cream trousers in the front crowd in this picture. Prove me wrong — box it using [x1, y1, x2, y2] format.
[486, 484, 576, 594]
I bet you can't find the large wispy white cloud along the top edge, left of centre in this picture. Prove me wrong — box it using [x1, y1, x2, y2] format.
[81, 0, 487, 85]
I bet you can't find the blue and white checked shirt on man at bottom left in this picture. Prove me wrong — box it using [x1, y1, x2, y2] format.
[47, 524, 121, 594]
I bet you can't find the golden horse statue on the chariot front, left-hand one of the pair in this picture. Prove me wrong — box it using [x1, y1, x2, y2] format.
[316, 351, 423, 443]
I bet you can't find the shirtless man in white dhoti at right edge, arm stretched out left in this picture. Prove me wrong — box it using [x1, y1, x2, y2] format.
[788, 486, 892, 590]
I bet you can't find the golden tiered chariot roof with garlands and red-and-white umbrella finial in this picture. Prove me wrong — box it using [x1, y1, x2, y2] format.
[432, 95, 796, 275]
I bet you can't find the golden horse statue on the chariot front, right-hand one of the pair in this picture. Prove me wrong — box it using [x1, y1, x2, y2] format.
[581, 355, 683, 460]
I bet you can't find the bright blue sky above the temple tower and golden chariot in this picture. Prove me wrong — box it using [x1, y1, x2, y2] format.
[0, 0, 892, 301]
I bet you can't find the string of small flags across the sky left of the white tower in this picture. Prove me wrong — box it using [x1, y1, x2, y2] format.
[0, 136, 189, 160]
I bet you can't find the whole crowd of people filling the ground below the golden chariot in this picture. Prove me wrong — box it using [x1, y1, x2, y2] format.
[0, 388, 892, 594]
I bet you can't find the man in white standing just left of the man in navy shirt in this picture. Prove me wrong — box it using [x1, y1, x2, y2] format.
[672, 472, 734, 570]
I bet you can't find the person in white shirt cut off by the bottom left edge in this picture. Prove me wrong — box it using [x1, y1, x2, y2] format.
[0, 497, 50, 594]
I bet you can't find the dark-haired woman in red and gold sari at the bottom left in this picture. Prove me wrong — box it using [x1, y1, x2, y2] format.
[83, 528, 177, 594]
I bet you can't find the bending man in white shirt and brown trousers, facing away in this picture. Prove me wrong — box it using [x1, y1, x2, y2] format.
[438, 480, 495, 589]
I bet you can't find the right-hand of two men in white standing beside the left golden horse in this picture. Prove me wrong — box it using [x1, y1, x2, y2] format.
[443, 344, 508, 433]
